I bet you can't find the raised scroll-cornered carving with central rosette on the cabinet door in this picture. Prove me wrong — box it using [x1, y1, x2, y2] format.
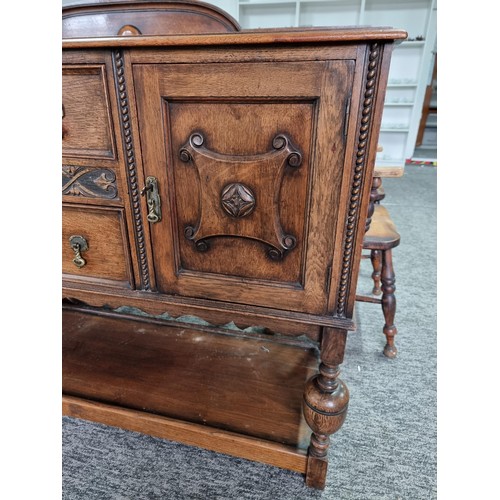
[178, 132, 302, 260]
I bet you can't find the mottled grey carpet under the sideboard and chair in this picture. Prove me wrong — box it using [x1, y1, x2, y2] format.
[63, 166, 437, 500]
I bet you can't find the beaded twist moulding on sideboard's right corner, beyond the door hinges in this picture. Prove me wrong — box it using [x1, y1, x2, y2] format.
[337, 43, 380, 316]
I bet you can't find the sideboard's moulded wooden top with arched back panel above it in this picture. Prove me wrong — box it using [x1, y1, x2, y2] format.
[62, 0, 407, 49]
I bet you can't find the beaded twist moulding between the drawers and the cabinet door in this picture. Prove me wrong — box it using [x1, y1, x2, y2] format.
[113, 50, 151, 290]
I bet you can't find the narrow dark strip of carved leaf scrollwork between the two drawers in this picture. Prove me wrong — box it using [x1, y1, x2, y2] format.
[62, 165, 118, 200]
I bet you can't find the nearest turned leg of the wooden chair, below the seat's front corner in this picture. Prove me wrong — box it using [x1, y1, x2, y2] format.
[381, 249, 398, 358]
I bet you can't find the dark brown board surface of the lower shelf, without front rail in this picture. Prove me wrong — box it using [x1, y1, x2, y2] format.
[63, 310, 317, 449]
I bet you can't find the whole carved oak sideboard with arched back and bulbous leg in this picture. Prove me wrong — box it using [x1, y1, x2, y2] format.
[62, 1, 406, 488]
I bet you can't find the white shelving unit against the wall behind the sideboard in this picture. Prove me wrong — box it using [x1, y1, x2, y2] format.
[205, 0, 437, 166]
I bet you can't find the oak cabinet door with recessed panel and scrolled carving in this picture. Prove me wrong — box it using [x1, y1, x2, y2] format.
[133, 60, 354, 313]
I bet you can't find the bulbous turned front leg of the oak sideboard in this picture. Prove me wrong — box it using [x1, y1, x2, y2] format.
[303, 328, 349, 489]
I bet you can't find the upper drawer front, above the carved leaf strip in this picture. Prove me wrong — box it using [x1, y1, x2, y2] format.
[62, 64, 116, 159]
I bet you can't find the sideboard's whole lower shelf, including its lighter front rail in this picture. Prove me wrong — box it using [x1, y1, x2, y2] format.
[63, 309, 318, 472]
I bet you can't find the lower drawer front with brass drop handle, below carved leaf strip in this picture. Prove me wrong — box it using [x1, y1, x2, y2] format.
[62, 205, 133, 288]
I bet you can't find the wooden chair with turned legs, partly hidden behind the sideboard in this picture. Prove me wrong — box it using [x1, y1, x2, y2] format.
[356, 177, 400, 358]
